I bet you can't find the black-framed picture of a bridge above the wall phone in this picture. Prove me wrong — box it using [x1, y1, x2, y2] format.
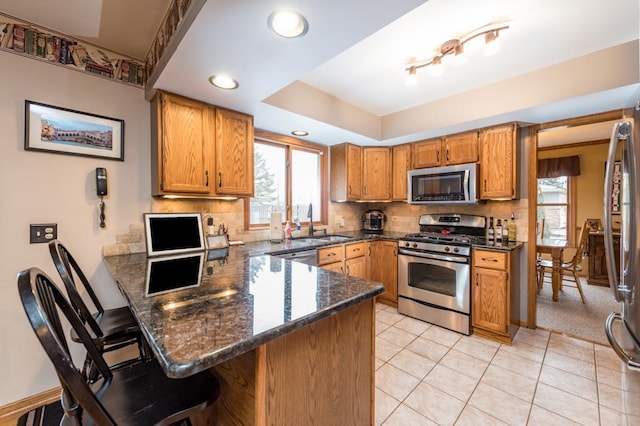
[24, 100, 124, 161]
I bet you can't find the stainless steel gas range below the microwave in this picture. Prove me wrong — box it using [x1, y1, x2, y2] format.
[398, 213, 487, 335]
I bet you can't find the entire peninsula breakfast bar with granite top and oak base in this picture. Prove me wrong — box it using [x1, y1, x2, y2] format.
[104, 247, 384, 425]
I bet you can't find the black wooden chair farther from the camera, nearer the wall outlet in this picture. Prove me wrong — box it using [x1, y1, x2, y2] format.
[49, 240, 153, 377]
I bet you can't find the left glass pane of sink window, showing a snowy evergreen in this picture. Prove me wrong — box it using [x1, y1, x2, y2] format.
[249, 143, 286, 225]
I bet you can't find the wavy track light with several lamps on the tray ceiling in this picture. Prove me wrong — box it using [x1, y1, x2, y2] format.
[405, 22, 509, 86]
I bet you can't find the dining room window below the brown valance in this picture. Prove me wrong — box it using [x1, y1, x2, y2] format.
[537, 176, 575, 245]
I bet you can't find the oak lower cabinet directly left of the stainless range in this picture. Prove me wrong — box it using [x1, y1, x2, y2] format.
[368, 240, 398, 307]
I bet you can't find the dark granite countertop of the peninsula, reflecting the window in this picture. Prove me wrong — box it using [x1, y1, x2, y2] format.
[104, 248, 384, 377]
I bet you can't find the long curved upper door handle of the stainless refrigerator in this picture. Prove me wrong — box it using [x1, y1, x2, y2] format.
[604, 123, 623, 302]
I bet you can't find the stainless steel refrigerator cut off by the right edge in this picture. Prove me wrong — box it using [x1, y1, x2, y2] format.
[604, 103, 640, 370]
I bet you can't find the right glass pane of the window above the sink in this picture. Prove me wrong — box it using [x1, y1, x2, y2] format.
[291, 149, 321, 222]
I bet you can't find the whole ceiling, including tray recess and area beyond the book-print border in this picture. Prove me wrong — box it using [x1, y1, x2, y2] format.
[0, 0, 640, 145]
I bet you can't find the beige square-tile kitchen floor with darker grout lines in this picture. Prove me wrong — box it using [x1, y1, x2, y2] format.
[375, 304, 640, 426]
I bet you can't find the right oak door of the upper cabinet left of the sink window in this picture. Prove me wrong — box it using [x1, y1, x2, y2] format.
[215, 109, 253, 196]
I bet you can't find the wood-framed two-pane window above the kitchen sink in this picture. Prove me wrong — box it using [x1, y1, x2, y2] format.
[245, 131, 327, 229]
